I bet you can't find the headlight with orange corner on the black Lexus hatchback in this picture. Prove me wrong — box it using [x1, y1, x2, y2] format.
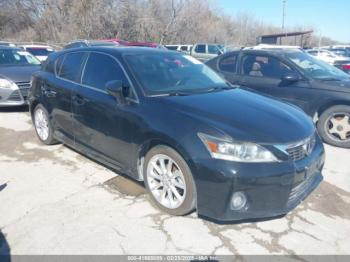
[198, 133, 278, 163]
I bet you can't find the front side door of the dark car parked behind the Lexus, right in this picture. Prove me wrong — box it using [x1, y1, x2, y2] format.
[239, 53, 314, 112]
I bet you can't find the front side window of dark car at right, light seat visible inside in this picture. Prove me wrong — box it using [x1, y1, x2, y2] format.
[242, 55, 292, 78]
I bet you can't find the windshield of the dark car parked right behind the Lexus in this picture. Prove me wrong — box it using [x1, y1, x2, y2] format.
[286, 52, 350, 81]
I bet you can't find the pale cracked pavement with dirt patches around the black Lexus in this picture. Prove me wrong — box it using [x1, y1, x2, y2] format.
[0, 110, 350, 254]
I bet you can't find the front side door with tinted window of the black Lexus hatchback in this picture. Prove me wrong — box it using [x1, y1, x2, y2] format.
[72, 52, 137, 168]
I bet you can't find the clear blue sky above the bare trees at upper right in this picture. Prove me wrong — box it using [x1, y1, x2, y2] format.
[217, 0, 350, 43]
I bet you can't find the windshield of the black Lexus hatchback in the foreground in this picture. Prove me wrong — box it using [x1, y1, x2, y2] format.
[126, 52, 230, 96]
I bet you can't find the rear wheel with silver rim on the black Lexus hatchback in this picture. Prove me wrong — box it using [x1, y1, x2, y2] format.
[33, 104, 58, 145]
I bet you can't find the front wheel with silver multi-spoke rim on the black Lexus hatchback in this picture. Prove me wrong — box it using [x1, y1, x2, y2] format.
[143, 146, 196, 216]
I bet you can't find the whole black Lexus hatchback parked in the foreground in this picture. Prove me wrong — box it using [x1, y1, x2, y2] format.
[29, 47, 324, 220]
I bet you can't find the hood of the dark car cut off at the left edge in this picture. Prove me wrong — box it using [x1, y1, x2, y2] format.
[0, 65, 40, 82]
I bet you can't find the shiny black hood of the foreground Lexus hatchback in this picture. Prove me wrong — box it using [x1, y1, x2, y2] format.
[161, 88, 315, 144]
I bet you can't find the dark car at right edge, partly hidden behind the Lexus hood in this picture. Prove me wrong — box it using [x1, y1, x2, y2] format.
[207, 49, 350, 147]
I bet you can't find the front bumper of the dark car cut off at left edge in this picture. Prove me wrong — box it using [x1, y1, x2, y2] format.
[0, 87, 29, 107]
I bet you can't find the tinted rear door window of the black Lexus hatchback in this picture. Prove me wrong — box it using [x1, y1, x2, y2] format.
[59, 52, 85, 82]
